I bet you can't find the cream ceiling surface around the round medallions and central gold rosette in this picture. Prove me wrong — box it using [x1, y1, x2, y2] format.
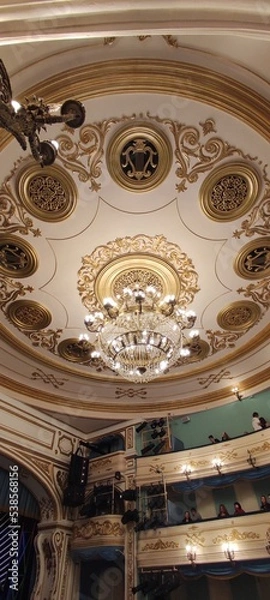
[0, 2, 270, 433]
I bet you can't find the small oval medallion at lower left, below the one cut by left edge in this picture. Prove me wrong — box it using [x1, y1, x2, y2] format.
[7, 300, 52, 331]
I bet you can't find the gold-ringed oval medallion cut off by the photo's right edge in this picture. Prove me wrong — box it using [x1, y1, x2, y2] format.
[234, 237, 270, 279]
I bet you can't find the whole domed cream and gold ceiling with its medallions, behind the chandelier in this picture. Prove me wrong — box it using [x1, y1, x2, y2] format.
[0, 3, 270, 432]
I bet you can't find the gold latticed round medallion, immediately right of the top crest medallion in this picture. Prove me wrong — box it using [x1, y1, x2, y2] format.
[200, 162, 259, 221]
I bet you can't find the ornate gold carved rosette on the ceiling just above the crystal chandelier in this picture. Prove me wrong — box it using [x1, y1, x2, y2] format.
[78, 234, 199, 311]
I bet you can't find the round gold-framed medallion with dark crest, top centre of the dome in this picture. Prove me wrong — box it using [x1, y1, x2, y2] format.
[106, 123, 172, 192]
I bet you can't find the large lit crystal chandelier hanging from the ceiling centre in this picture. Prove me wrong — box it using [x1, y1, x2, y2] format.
[82, 286, 199, 383]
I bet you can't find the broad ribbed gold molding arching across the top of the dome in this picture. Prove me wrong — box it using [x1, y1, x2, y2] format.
[0, 58, 270, 149]
